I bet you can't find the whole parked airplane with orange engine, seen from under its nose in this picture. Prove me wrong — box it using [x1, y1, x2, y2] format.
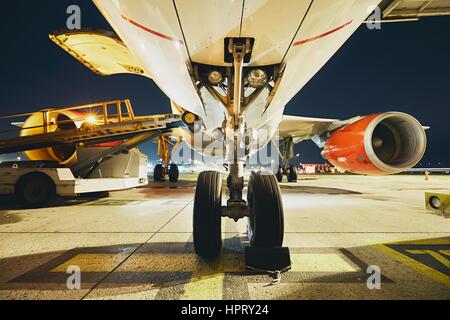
[37, 0, 450, 259]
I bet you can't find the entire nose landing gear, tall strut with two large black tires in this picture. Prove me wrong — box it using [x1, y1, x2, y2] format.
[194, 38, 284, 260]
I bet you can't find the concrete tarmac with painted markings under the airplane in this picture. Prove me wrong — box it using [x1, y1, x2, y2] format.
[0, 174, 450, 300]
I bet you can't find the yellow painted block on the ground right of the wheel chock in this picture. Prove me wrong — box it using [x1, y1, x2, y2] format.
[291, 253, 358, 273]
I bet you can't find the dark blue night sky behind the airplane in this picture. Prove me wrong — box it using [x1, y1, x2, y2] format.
[0, 0, 450, 166]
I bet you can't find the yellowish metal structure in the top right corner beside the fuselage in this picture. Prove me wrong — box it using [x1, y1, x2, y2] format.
[380, 0, 450, 22]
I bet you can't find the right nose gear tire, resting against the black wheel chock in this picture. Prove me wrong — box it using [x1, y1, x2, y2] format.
[247, 172, 284, 248]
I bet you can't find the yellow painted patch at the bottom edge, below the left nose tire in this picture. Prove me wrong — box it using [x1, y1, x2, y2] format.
[181, 273, 225, 300]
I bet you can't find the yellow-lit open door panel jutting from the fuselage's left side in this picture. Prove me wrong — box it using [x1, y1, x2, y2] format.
[50, 30, 151, 78]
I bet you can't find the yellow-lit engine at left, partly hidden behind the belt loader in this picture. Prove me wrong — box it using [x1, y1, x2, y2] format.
[20, 111, 82, 165]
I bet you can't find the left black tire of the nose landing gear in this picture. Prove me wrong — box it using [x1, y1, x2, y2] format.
[194, 171, 222, 260]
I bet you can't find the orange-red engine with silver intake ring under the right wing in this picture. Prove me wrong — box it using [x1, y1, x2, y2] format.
[322, 112, 427, 175]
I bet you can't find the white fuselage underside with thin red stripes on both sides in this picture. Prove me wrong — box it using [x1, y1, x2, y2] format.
[93, 0, 380, 154]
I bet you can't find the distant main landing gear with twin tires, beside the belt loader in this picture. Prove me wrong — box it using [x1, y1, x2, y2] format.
[153, 136, 180, 182]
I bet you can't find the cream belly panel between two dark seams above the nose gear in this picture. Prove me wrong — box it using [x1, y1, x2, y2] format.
[175, 0, 310, 66]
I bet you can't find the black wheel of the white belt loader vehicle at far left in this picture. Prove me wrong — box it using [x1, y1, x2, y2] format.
[15, 172, 56, 209]
